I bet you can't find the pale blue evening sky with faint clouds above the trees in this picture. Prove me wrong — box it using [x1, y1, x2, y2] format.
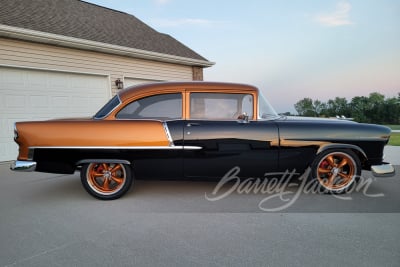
[86, 0, 400, 113]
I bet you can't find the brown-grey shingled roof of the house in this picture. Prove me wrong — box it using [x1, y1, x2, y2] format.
[0, 0, 207, 61]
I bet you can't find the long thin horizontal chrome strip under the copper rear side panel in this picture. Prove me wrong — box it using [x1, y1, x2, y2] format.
[29, 146, 203, 150]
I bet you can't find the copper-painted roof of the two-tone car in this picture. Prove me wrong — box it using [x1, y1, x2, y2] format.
[118, 81, 258, 101]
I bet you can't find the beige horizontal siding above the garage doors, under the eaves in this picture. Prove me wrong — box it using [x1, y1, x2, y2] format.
[0, 38, 193, 95]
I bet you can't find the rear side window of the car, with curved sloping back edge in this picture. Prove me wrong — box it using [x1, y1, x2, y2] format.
[116, 93, 182, 120]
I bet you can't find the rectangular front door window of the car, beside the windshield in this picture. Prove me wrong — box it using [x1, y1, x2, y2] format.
[190, 93, 253, 120]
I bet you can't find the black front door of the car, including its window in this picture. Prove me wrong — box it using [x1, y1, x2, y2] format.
[183, 92, 278, 178]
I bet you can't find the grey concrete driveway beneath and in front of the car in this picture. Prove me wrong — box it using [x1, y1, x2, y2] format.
[0, 147, 400, 266]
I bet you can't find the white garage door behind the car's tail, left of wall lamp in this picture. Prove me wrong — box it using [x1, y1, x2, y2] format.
[0, 67, 111, 161]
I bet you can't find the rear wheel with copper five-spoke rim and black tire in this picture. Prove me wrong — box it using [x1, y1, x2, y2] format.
[81, 162, 133, 200]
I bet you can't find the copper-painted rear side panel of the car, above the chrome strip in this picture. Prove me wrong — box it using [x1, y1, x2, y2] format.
[16, 120, 169, 160]
